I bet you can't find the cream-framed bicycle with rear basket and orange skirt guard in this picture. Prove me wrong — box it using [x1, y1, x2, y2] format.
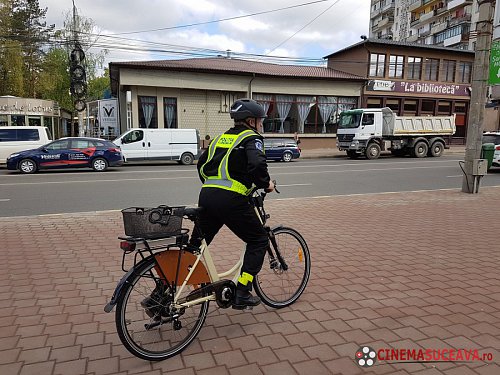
[104, 184, 311, 361]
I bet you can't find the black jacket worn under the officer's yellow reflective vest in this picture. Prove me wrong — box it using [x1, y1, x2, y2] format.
[197, 125, 271, 188]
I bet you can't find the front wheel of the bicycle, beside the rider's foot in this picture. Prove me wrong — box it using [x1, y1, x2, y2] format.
[253, 227, 311, 309]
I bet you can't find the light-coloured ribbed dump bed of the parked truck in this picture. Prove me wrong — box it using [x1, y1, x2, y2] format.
[382, 111, 455, 136]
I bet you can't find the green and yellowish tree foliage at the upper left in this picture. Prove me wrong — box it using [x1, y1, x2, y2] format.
[0, 0, 109, 110]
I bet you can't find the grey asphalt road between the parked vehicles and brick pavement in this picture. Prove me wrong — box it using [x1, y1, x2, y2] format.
[0, 155, 500, 217]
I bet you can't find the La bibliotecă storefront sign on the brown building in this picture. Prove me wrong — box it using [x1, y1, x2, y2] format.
[366, 80, 470, 96]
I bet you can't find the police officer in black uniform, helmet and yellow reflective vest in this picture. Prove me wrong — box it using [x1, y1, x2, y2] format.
[194, 99, 274, 309]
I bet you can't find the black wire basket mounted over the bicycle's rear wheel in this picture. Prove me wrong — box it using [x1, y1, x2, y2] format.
[122, 206, 184, 239]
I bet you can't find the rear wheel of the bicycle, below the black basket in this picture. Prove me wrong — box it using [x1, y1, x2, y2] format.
[116, 259, 209, 361]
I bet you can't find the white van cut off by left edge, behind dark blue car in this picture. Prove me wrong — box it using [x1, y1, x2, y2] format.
[0, 126, 52, 164]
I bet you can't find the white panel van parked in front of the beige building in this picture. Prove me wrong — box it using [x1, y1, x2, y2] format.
[113, 128, 200, 165]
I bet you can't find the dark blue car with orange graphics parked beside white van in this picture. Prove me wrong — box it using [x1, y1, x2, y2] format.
[7, 137, 123, 173]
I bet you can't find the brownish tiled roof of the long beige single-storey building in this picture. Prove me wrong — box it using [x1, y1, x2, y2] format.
[110, 57, 365, 80]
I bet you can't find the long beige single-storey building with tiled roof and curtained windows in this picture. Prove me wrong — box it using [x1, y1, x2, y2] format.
[109, 57, 366, 147]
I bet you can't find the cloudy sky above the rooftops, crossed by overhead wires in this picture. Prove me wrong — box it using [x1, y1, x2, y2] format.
[39, 0, 370, 65]
